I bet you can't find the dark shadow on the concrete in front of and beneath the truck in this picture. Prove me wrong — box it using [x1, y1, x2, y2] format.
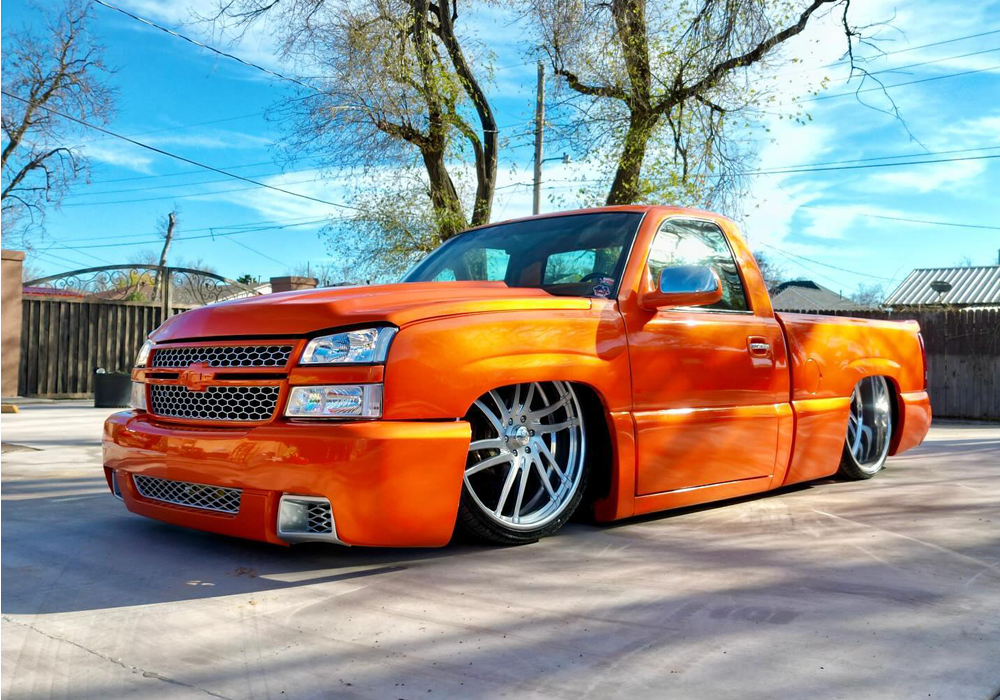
[0, 475, 828, 614]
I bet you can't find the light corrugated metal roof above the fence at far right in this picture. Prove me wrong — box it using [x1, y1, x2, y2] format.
[885, 265, 1000, 306]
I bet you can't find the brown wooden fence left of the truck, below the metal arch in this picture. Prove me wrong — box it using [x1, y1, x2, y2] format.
[17, 297, 194, 398]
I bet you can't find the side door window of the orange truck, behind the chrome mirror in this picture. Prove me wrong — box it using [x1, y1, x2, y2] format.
[647, 219, 750, 311]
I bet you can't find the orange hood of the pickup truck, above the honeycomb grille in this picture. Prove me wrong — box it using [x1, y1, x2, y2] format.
[149, 282, 591, 342]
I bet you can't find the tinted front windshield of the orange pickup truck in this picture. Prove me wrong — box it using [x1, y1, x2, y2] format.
[402, 212, 642, 297]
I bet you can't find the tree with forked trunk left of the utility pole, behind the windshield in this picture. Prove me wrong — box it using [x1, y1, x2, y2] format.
[212, 0, 499, 240]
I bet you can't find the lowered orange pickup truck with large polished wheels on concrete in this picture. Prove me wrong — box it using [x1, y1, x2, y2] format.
[104, 206, 931, 546]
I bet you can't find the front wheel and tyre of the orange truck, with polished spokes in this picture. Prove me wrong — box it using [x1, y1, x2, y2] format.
[459, 382, 586, 543]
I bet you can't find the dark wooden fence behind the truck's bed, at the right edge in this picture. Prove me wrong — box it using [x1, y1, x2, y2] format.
[788, 308, 1000, 420]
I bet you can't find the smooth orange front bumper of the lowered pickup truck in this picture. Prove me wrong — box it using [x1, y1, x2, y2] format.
[104, 411, 470, 547]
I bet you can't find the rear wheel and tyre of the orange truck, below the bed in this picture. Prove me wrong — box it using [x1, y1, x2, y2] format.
[840, 377, 892, 479]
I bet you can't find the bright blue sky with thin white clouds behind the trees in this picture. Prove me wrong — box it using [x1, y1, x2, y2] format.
[2, 0, 1000, 293]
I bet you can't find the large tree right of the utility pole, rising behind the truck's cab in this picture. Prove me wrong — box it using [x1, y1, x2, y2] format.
[528, 0, 876, 205]
